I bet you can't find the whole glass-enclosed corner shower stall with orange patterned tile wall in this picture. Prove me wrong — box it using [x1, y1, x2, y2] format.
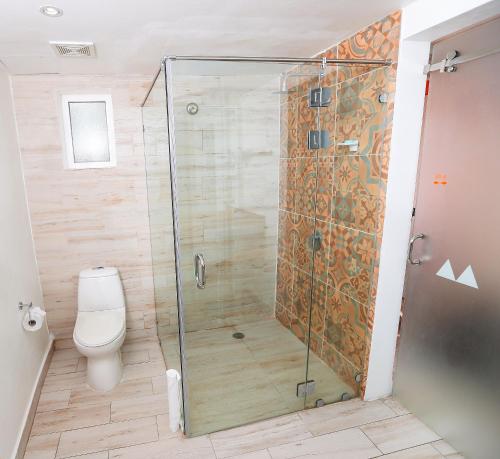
[143, 56, 390, 436]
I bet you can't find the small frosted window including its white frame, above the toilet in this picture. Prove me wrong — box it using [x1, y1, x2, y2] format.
[62, 95, 116, 169]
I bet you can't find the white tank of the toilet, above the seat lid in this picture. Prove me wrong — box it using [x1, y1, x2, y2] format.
[78, 266, 125, 311]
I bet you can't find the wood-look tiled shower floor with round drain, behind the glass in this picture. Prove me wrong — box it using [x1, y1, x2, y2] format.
[165, 319, 354, 435]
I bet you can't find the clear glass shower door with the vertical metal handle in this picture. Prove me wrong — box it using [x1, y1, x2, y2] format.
[167, 60, 319, 435]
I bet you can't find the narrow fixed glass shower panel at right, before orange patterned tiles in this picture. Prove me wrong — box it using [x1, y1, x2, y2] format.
[306, 65, 392, 407]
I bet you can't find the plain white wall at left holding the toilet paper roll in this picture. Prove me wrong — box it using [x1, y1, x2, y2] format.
[0, 63, 49, 458]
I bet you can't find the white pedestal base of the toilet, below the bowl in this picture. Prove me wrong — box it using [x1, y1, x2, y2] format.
[87, 350, 122, 391]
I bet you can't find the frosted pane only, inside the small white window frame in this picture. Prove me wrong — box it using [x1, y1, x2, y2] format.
[69, 102, 110, 163]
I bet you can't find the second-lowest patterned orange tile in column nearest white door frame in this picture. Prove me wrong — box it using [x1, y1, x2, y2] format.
[325, 287, 370, 368]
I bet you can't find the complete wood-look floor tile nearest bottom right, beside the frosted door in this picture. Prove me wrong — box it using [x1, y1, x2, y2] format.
[361, 414, 440, 454]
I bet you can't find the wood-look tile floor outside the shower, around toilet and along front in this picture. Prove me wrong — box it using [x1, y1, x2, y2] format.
[25, 339, 462, 459]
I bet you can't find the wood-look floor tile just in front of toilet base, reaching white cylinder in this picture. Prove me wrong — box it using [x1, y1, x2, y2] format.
[111, 394, 168, 422]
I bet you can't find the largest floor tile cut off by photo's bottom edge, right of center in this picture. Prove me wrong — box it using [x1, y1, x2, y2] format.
[269, 429, 380, 459]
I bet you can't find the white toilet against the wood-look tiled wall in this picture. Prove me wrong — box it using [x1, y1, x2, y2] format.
[73, 267, 126, 391]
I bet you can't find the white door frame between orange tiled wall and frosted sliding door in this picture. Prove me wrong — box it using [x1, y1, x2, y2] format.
[364, 0, 500, 400]
